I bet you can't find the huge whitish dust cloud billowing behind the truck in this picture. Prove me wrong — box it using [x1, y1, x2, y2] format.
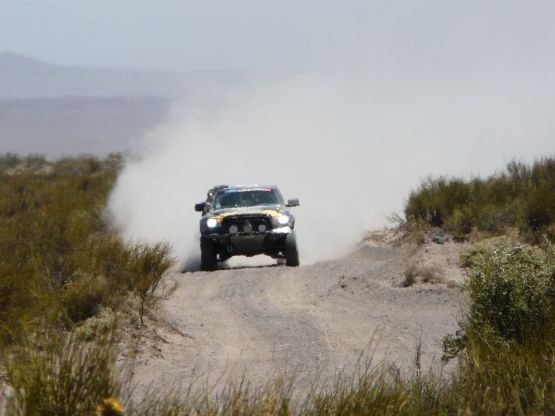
[109, 2, 555, 264]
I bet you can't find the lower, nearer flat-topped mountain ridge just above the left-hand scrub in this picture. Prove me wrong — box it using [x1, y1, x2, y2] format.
[0, 96, 171, 158]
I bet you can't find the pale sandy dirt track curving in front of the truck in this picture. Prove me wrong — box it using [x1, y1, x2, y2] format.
[130, 230, 470, 398]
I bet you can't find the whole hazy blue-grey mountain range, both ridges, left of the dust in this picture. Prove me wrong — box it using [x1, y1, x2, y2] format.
[0, 52, 248, 157]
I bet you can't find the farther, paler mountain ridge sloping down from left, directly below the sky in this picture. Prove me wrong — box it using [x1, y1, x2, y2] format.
[0, 52, 242, 99]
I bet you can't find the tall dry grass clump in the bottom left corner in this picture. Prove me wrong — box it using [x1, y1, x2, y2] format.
[7, 336, 121, 416]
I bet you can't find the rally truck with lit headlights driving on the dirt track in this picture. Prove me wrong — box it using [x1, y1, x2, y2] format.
[195, 185, 299, 271]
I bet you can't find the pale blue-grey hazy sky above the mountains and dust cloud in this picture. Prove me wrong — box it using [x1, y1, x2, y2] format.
[0, 0, 555, 70]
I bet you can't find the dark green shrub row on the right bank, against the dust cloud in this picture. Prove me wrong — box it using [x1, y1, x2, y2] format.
[405, 157, 555, 243]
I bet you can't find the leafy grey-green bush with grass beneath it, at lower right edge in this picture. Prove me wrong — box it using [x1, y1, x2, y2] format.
[438, 238, 555, 415]
